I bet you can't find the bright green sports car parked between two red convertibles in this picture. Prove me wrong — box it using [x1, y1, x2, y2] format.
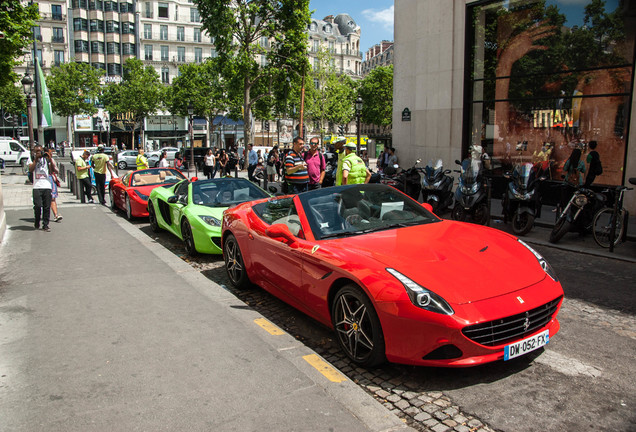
[148, 177, 271, 255]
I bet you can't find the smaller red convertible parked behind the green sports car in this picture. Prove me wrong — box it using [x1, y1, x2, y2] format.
[108, 168, 186, 219]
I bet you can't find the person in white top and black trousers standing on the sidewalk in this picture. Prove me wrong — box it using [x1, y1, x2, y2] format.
[29, 145, 53, 232]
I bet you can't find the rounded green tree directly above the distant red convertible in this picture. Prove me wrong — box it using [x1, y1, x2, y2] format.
[102, 57, 165, 146]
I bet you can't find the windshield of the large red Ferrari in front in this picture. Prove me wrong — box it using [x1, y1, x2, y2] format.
[298, 184, 440, 240]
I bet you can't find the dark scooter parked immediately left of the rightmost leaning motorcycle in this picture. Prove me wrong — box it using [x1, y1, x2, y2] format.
[503, 163, 546, 236]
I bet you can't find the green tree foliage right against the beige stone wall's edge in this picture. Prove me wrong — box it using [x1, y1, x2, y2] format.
[358, 65, 393, 132]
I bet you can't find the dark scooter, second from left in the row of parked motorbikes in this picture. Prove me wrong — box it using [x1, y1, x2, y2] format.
[451, 158, 490, 225]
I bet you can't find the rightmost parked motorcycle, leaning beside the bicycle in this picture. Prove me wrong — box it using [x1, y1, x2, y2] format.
[550, 187, 607, 243]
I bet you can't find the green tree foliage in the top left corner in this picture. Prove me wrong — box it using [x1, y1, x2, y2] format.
[0, 0, 40, 86]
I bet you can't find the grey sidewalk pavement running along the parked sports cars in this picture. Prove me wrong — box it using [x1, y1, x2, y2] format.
[0, 177, 410, 431]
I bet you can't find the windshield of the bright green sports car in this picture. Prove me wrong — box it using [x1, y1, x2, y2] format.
[192, 178, 270, 207]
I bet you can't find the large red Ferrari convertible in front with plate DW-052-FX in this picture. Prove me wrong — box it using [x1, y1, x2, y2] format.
[222, 184, 563, 367]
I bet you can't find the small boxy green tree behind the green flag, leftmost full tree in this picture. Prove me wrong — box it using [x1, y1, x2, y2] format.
[46, 62, 104, 147]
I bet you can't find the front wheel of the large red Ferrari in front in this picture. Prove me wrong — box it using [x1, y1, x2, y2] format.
[331, 284, 386, 367]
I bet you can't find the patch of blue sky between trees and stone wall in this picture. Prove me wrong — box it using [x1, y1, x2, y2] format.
[309, 0, 394, 53]
